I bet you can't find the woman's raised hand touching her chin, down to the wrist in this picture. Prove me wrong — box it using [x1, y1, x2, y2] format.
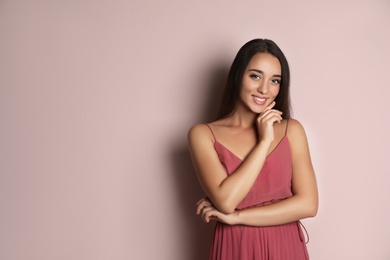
[256, 101, 283, 144]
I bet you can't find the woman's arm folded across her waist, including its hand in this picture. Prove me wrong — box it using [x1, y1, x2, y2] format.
[197, 120, 318, 226]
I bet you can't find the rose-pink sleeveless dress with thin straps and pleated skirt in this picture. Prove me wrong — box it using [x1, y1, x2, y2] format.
[207, 122, 309, 260]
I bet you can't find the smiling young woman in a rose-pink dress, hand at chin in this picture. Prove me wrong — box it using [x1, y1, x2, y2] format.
[188, 39, 318, 260]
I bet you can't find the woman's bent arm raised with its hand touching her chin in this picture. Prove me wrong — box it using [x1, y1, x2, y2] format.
[188, 103, 282, 213]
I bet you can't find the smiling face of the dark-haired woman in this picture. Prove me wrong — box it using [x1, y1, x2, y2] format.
[240, 52, 282, 114]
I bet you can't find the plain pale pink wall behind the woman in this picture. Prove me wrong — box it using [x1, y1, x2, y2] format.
[0, 0, 390, 260]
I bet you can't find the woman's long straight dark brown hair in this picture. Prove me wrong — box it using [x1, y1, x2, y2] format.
[217, 39, 291, 119]
